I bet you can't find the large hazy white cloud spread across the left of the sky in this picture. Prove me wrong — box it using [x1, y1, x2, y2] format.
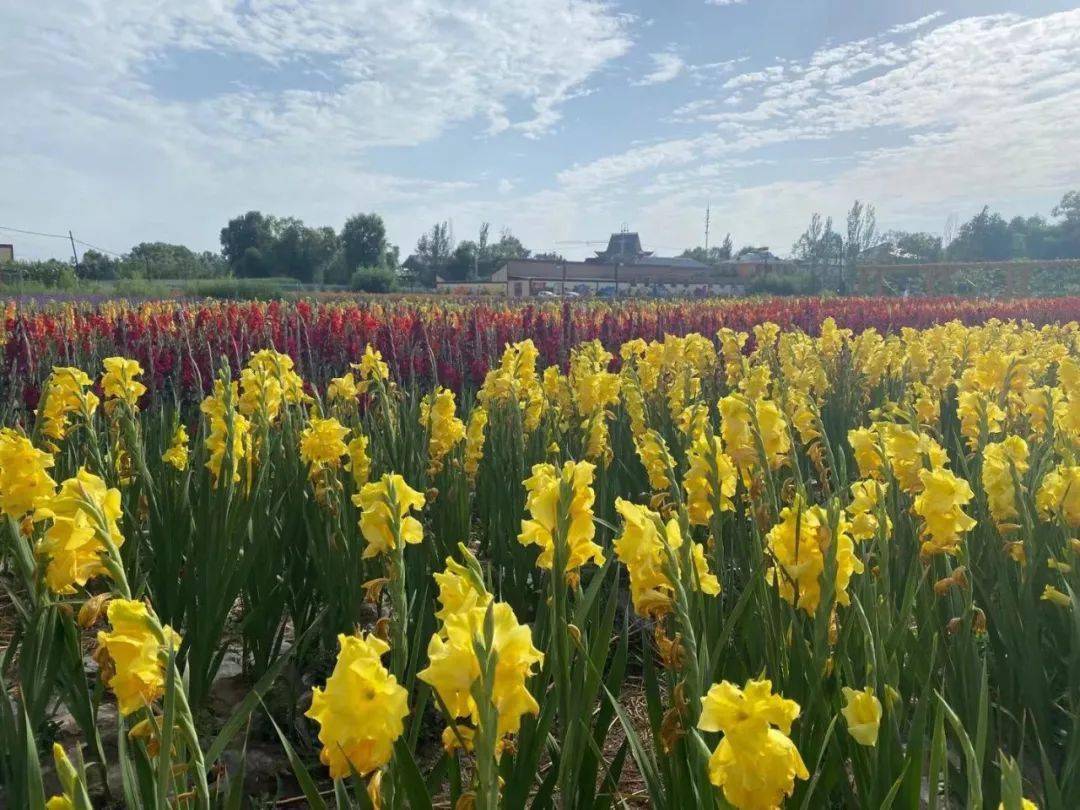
[0, 0, 631, 257]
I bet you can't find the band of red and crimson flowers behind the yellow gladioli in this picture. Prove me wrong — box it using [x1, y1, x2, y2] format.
[0, 297, 1080, 407]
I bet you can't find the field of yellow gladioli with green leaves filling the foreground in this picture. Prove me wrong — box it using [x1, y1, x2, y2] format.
[0, 319, 1080, 810]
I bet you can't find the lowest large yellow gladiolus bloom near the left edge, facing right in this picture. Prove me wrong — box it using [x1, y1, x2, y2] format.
[95, 599, 180, 717]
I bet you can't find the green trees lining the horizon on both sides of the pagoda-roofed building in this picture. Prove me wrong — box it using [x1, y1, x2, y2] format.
[8, 191, 1080, 289]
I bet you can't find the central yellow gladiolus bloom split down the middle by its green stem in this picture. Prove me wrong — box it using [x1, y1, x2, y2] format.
[517, 461, 604, 573]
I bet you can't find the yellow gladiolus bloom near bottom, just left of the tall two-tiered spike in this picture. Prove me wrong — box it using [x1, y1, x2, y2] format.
[305, 634, 408, 779]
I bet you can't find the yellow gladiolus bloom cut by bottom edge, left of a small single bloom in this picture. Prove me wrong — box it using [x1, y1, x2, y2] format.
[698, 680, 810, 810]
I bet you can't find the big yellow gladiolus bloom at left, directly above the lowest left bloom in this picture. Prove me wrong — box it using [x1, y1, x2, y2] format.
[33, 468, 124, 594]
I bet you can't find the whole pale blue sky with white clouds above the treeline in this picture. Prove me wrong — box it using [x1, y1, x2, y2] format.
[0, 0, 1080, 257]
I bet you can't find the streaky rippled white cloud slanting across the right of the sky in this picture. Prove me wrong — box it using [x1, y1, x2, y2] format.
[559, 10, 1080, 249]
